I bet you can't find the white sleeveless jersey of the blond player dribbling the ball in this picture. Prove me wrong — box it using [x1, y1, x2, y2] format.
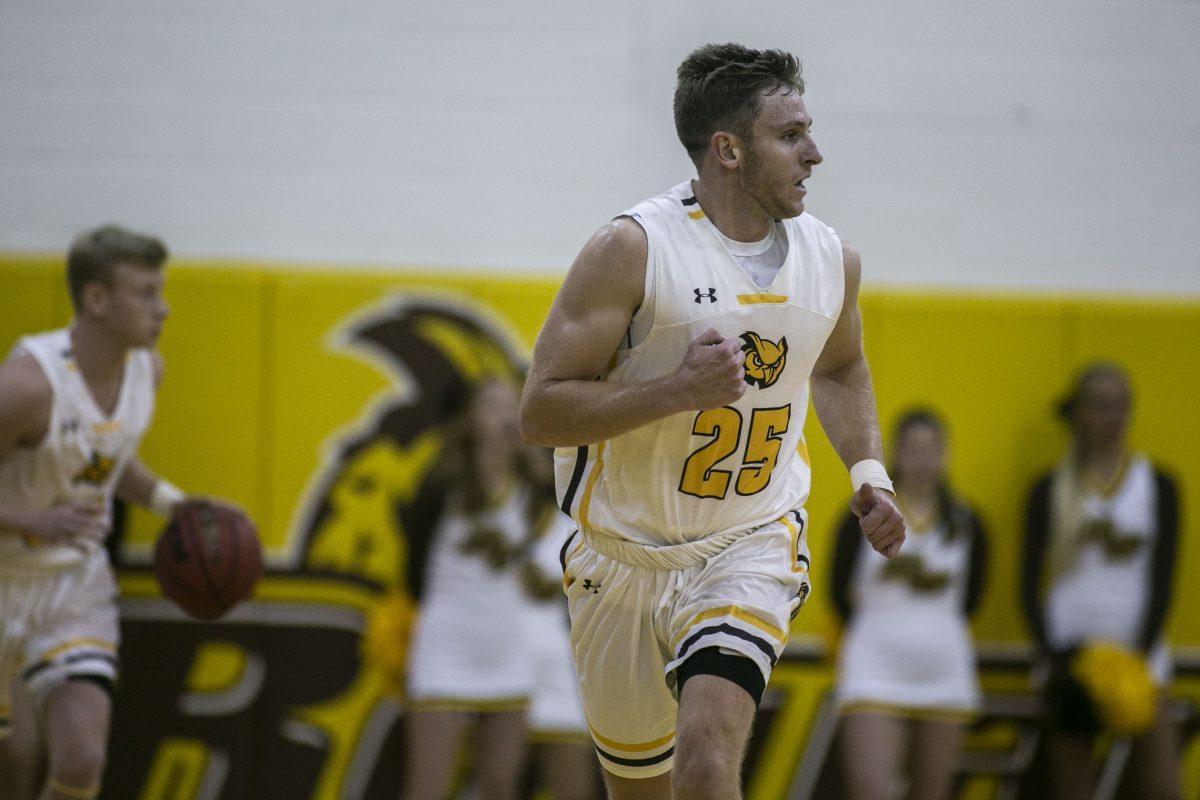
[0, 329, 155, 566]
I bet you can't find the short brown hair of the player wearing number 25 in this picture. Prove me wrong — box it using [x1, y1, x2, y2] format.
[674, 43, 804, 167]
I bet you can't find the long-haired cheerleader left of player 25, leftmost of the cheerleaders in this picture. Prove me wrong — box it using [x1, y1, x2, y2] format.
[402, 379, 542, 800]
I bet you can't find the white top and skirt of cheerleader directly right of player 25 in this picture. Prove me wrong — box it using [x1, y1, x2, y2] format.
[836, 525, 980, 711]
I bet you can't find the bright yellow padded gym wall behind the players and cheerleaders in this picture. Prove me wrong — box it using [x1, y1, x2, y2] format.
[0, 254, 1200, 798]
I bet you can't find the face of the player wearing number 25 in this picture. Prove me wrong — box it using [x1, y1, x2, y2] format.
[742, 91, 821, 219]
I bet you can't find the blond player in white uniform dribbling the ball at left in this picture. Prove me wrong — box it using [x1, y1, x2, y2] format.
[0, 225, 184, 800]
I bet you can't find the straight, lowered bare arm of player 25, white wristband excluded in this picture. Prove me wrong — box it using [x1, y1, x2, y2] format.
[811, 242, 905, 558]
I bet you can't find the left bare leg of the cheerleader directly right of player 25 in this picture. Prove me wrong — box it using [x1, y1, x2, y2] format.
[838, 711, 910, 800]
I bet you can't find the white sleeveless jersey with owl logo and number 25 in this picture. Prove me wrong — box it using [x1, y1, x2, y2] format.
[556, 182, 845, 546]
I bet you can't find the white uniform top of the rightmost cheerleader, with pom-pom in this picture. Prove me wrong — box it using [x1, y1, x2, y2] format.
[1045, 456, 1171, 682]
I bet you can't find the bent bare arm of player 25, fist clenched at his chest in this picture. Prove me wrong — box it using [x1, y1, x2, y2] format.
[521, 217, 746, 447]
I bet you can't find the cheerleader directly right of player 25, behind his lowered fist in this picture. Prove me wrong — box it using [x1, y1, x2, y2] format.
[832, 409, 986, 800]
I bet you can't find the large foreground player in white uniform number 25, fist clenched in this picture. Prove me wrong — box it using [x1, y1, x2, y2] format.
[522, 44, 905, 800]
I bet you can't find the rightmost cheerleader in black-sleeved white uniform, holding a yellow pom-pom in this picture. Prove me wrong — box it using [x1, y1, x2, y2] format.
[1021, 363, 1181, 800]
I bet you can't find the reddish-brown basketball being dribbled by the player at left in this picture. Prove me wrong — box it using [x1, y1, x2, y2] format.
[154, 500, 263, 620]
